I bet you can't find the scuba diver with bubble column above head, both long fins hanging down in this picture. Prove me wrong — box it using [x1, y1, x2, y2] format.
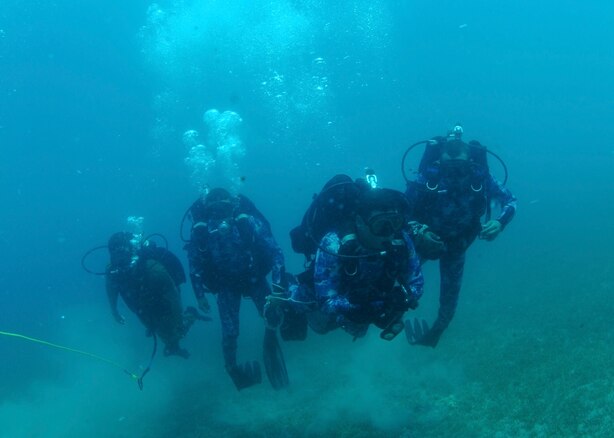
[185, 188, 288, 390]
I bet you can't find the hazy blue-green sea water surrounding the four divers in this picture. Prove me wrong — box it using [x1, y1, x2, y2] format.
[0, 0, 614, 437]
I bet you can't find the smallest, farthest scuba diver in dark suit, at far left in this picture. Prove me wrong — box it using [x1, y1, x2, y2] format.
[105, 232, 209, 359]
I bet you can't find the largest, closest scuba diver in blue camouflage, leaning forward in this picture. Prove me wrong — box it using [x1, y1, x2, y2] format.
[265, 175, 423, 340]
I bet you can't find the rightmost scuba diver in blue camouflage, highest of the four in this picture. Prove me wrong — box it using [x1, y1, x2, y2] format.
[402, 124, 516, 348]
